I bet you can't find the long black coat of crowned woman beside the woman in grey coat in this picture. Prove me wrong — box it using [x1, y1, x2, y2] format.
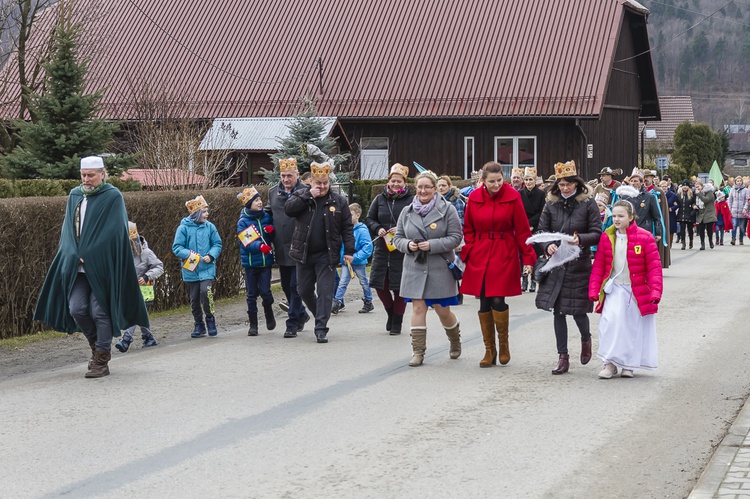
[365, 192, 414, 291]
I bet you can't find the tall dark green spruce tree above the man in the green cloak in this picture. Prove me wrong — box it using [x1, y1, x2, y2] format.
[3, 19, 117, 179]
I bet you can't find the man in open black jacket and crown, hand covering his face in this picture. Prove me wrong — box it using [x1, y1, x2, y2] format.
[284, 162, 354, 343]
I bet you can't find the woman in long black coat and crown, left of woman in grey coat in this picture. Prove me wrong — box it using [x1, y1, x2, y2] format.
[365, 163, 414, 336]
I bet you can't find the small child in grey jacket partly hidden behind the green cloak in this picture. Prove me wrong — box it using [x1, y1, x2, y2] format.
[115, 222, 164, 353]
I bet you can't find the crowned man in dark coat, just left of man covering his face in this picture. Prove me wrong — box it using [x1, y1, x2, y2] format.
[266, 158, 310, 338]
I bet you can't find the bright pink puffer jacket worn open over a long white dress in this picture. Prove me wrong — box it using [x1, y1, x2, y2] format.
[589, 223, 664, 316]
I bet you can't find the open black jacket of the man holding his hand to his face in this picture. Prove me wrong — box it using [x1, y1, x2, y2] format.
[284, 189, 354, 267]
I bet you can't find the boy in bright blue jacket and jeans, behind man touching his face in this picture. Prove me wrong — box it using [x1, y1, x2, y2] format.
[331, 203, 374, 314]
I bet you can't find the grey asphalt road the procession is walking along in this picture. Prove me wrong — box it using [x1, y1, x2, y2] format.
[0, 246, 750, 498]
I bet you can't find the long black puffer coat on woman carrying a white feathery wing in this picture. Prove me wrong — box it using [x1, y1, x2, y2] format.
[536, 188, 602, 315]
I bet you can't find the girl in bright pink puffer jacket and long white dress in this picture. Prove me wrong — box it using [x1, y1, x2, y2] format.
[589, 201, 663, 379]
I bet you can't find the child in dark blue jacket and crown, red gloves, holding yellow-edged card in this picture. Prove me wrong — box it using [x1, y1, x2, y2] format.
[237, 186, 276, 336]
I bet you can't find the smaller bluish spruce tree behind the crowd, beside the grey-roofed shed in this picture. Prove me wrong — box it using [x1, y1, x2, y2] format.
[261, 100, 349, 184]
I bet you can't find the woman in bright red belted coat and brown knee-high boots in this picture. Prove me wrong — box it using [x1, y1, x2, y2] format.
[461, 162, 536, 367]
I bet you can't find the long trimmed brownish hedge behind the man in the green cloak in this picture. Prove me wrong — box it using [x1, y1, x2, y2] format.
[0, 186, 268, 338]
